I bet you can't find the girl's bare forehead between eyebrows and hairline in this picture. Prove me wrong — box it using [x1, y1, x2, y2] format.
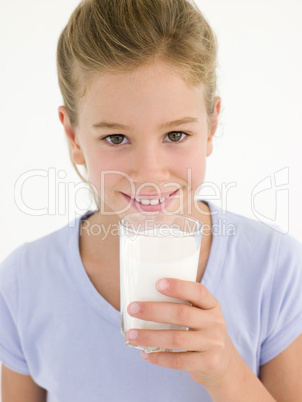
[79, 62, 206, 124]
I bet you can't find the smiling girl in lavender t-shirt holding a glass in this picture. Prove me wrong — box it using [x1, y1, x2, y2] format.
[0, 0, 302, 402]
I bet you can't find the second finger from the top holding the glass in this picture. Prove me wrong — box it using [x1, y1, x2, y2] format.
[127, 302, 214, 329]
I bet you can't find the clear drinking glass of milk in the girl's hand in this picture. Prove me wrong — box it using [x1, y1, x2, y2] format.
[119, 212, 203, 353]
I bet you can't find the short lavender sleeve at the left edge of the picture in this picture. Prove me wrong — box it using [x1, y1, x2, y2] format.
[0, 248, 30, 375]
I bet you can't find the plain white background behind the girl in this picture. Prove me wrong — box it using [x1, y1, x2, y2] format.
[0, 0, 302, 390]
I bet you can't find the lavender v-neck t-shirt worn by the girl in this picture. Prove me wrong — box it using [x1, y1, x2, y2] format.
[0, 202, 302, 402]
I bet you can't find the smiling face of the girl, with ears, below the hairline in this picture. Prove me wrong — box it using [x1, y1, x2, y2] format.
[59, 62, 220, 221]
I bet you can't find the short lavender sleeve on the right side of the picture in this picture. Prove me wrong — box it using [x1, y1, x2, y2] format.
[260, 234, 302, 365]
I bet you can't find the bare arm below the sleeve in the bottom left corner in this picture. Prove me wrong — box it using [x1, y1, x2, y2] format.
[1, 365, 46, 402]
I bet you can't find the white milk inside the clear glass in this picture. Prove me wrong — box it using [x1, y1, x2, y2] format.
[120, 231, 201, 334]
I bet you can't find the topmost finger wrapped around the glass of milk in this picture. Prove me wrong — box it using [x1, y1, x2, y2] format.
[156, 278, 219, 310]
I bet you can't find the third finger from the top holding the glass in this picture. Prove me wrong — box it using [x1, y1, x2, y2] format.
[126, 329, 213, 352]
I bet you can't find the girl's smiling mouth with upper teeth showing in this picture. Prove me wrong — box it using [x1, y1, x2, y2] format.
[122, 188, 179, 212]
